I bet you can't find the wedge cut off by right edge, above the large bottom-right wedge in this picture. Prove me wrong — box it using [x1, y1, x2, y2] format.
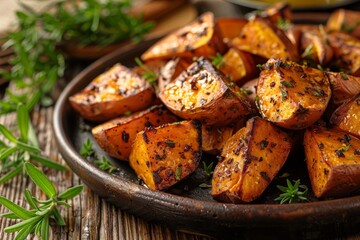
[330, 93, 360, 138]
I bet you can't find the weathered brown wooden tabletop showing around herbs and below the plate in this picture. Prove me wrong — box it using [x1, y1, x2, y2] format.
[0, 98, 211, 240]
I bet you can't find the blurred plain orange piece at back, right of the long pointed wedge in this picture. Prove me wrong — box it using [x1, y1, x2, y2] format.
[215, 17, 248, 43]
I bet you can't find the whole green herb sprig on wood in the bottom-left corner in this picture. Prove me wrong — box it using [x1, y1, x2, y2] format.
[0, 162, 83, 240]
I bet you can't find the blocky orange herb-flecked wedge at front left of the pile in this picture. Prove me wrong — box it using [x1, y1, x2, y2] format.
[129, 120, 202, 190]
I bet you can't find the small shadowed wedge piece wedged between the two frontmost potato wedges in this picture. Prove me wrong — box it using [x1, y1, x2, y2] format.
[201, 125, 234, 154]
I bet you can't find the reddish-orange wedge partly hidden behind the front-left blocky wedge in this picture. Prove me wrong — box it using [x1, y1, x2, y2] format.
[92, 106, 178, 161]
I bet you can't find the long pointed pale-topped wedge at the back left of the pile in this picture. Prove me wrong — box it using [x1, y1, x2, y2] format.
[141, 12, 225, 61]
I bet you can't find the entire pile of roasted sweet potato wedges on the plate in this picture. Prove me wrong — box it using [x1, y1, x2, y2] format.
[69, 4, 360, 203]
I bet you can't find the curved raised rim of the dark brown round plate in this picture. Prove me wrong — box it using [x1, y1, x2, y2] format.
[53, 26, 360, 236]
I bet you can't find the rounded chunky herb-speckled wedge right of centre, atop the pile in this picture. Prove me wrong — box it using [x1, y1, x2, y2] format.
[257, 59, 331, 129]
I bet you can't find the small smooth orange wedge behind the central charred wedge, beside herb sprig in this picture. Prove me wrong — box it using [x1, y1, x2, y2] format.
[219, 48, 257, 85]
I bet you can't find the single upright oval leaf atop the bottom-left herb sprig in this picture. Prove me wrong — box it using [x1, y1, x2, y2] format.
[25, 162, 56, 198]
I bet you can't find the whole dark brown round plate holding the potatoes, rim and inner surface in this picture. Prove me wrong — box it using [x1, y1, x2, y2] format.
[53, 38, 360, 236]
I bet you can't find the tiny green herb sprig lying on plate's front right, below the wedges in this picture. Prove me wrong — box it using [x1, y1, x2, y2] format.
[275, 179, 308, 204]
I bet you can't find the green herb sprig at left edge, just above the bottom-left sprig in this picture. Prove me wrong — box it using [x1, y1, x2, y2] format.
[0, 104, 66, 184]
